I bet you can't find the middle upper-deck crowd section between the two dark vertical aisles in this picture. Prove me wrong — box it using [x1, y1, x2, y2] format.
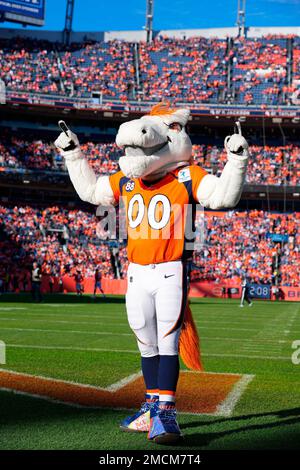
[140, 38, 228, 103]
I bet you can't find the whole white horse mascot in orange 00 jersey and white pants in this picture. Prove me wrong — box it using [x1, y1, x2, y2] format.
[55, 104, 249, 444]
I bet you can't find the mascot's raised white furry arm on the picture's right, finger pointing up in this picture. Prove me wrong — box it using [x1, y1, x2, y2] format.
[197, 122, 249, 209]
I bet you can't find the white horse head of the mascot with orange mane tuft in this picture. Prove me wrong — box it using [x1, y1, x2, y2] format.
[116, 103, 192, 179]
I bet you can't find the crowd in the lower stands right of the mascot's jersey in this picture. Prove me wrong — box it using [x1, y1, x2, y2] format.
[192, 210, 300, 287]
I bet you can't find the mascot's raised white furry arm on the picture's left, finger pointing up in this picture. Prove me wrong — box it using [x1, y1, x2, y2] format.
[55, 121, 115, 206]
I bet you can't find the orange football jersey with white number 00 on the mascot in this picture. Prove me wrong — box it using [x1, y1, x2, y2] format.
[110, 165, 207, 265]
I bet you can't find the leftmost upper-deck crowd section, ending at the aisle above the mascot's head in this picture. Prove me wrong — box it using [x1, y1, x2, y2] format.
[0, 38, 134, 100]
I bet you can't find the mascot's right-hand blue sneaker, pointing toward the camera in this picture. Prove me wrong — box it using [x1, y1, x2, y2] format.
[148, 402, 183, 444]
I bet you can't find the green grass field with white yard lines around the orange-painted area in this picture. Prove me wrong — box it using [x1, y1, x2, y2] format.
[0, 295, 300, 450]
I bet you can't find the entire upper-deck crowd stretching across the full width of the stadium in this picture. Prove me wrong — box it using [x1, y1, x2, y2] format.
[0, 36, 300, 105]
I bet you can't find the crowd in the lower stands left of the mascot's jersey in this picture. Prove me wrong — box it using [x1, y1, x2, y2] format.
[0, 206, 114, 290]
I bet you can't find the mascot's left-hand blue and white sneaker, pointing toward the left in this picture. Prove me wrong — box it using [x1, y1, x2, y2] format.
[120, 400, 158, 432]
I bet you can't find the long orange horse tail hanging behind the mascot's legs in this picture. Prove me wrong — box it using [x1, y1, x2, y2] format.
[179, 302, 203, 370]
